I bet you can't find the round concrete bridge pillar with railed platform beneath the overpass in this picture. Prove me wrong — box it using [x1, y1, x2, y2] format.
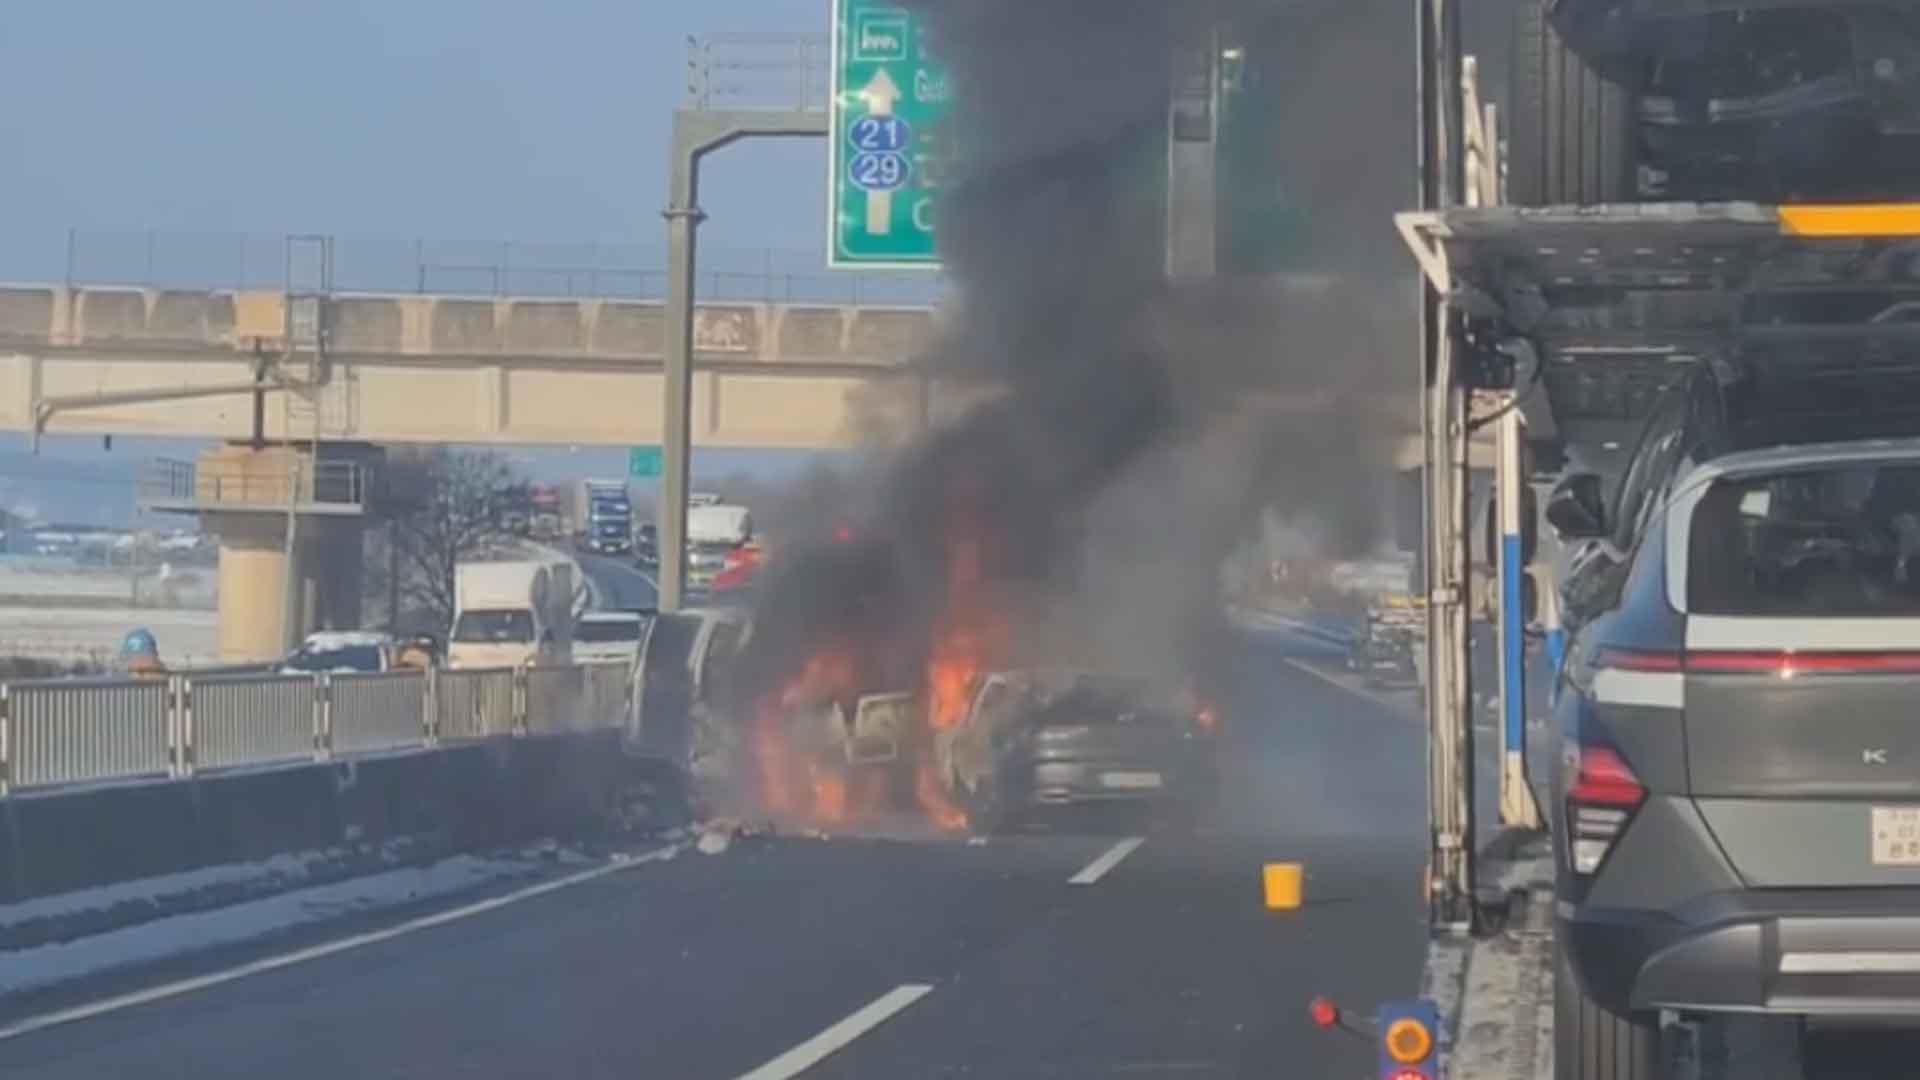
[142, 444, 378, 663]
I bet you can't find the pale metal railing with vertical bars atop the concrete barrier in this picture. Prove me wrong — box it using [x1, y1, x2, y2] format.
[0, 663, 632, 796]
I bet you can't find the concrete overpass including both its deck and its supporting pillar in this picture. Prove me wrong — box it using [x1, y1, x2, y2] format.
[0, 284, 1443, 659]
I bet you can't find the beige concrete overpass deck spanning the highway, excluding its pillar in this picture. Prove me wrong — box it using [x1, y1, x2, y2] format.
[0, 284, 943, 448]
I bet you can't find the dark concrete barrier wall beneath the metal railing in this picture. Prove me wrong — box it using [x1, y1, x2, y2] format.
[0, 732, 645, 903]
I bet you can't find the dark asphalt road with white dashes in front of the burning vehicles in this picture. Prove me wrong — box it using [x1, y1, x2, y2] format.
[0, 618, 1425, 1080]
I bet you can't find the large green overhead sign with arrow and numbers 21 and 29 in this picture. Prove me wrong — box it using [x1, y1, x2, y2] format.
[828, 0, 947, 269]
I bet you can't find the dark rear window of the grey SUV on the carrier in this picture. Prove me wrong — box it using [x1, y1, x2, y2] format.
[1688, 463, 1920, 615]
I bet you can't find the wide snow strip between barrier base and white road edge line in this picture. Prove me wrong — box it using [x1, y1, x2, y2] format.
[0, 851, 593, 995]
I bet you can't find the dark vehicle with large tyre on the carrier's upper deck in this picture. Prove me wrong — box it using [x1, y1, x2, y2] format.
[1507, 0, 1920, 204]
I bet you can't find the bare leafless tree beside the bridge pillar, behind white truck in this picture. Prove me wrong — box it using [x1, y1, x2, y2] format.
[388, 448, 520, 632]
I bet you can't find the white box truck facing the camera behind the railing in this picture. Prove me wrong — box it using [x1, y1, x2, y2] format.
[447, 561, 574, 669]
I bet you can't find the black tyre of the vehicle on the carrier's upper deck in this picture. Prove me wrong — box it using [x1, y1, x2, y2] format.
[1505, 0, 1638, 206]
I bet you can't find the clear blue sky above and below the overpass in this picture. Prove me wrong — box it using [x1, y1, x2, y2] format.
[0, 0, 856, 517]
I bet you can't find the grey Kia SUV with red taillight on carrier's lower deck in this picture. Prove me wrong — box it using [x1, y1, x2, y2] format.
[1548, 365, 1920, 1080]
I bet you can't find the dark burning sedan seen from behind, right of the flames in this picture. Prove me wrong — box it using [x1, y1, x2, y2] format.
[937, 671, 1219, 832]
